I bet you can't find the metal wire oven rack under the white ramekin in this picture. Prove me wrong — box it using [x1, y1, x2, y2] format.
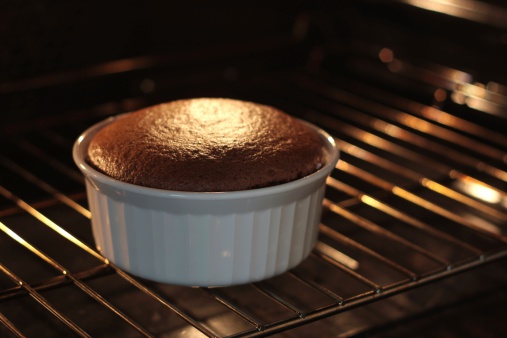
[0, 56, 507, 337]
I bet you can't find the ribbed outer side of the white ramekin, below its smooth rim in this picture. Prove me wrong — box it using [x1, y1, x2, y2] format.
[88, 178, 324, 286]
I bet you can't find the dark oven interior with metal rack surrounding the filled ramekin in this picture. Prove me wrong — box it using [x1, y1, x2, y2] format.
[0, 0, 507, 337]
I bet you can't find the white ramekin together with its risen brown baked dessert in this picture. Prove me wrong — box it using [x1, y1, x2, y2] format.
[72, 99, 339, 287]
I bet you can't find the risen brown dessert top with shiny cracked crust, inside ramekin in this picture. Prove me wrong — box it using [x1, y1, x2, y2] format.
[87, 98, 326, 192]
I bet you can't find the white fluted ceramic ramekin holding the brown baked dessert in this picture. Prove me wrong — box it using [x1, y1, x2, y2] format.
[73, 116, 339, 286]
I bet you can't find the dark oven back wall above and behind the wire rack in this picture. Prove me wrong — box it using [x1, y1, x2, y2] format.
[0, 1, 506, 125]
